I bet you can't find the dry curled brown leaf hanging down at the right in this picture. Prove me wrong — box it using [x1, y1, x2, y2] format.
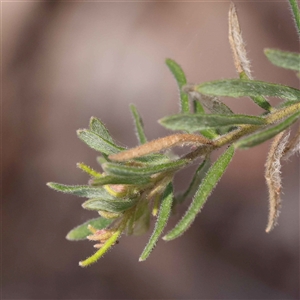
[265, 131, 290, 232]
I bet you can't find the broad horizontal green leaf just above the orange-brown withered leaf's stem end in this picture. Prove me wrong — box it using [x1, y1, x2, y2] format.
[159, 114, 265, 132]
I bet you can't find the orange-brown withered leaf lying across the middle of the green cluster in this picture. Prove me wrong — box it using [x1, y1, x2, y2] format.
[108, 134, 212, 161]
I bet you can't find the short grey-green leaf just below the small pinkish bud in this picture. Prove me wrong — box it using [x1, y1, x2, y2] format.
[82, 198, 137, 213]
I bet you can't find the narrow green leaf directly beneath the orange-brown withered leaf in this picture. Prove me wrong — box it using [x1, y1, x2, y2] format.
[103, 160, 188, 177]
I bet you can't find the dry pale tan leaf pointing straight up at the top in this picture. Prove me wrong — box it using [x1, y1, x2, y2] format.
[228, 3, 252, 79]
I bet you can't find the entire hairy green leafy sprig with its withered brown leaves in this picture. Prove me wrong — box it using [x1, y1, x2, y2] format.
[48, 0, 300, 267]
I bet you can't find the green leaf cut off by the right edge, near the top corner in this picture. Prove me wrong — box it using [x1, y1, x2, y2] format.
[264, 49, 300, 71]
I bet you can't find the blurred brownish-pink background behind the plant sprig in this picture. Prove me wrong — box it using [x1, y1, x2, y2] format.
[1, 1, 299, 299]
